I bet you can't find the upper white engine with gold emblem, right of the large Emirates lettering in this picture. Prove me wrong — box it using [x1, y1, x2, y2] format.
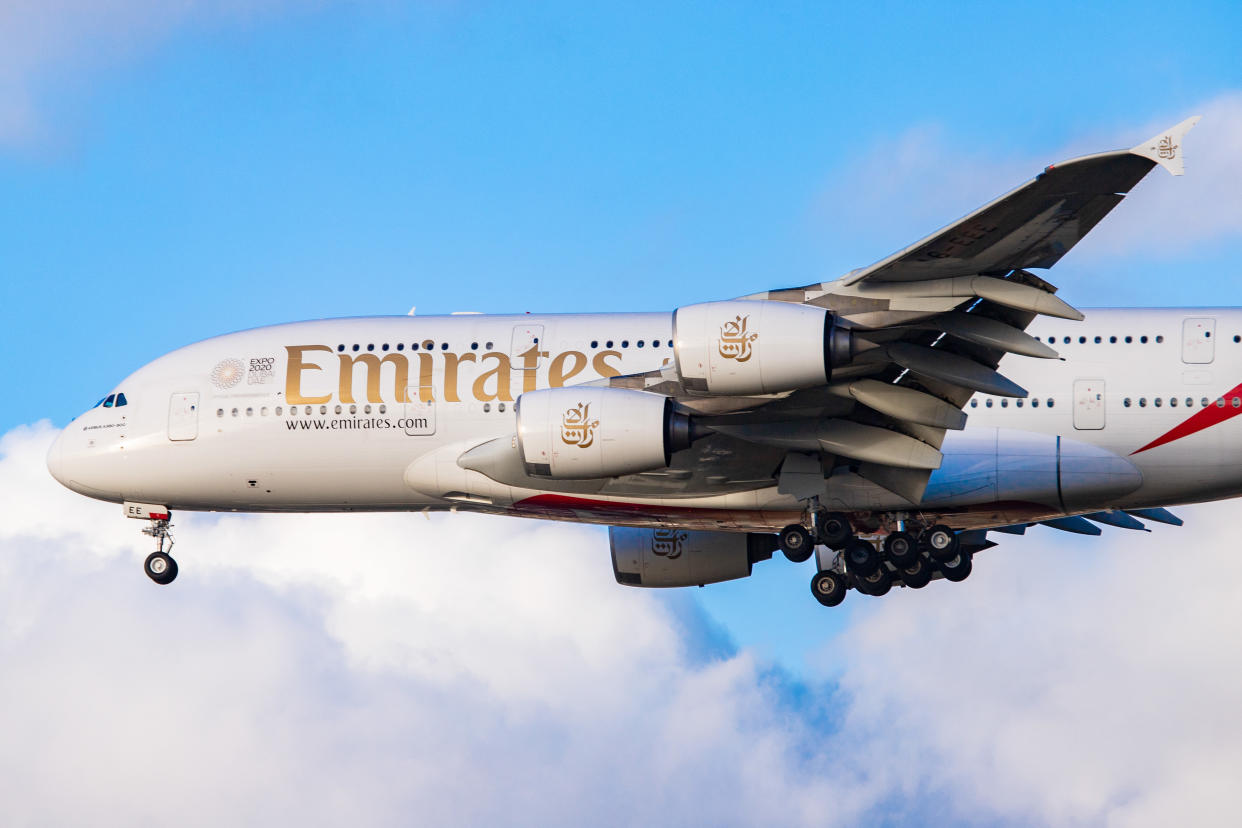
[673, 299, 853, 396]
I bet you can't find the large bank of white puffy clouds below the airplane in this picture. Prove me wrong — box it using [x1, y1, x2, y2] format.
[7, 426, 1242, 824]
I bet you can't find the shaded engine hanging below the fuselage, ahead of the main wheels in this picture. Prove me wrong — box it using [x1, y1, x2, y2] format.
[609, 526, 776, 587]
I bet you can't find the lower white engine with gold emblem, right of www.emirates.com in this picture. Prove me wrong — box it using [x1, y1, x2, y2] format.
[515, 386, 691, 480]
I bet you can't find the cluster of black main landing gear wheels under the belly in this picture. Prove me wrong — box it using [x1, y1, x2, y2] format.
[776, 503, 974, 607]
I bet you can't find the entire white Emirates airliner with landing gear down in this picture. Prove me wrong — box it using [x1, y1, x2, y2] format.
[47, 118, 1222, 606]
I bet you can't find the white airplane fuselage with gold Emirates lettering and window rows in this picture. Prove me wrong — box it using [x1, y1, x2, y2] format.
[48, 309, 1242, 529]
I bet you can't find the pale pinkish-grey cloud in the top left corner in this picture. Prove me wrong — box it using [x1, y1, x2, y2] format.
[0, 0, 323, 145]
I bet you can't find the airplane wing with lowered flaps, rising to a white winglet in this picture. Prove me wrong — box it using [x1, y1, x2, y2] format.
[601, 117, 1199, 504]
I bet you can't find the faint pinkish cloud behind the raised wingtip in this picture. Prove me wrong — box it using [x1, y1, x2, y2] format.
[814, 92, 1242, 267]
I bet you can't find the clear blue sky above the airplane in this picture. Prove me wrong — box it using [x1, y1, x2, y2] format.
[0, 1, 1242, 428]
